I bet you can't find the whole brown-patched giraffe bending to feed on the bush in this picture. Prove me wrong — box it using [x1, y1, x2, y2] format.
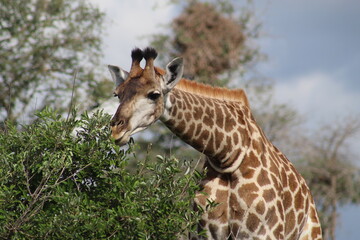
[108, 48, 322, 240]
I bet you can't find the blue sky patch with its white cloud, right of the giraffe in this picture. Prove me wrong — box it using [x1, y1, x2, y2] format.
[257, 0, 360, 125]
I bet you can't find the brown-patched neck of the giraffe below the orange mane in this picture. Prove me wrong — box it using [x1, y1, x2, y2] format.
[161, 88, 260, 172]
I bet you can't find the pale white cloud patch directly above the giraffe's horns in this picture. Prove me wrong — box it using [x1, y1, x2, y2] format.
[91, 0, 174, 69]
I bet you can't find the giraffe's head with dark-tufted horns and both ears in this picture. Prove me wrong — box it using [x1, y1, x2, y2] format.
[108, 48, 183, 145]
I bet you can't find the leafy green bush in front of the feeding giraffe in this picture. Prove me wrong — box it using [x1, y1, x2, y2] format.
[0, 110, 200, 239]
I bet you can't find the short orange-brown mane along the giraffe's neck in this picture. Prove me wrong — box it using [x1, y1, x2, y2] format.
[155, 67, 249, 107]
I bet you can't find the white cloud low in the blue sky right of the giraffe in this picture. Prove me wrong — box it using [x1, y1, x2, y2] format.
[275, 72, 360, 122]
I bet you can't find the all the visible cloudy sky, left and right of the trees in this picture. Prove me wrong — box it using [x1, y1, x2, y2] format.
[91, 0, 360, 240]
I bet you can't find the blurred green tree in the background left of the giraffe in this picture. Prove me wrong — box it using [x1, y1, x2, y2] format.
[0, 0, 109, 125]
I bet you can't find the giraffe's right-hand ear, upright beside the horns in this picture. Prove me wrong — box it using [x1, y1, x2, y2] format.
[164, 57, 184, 93]
